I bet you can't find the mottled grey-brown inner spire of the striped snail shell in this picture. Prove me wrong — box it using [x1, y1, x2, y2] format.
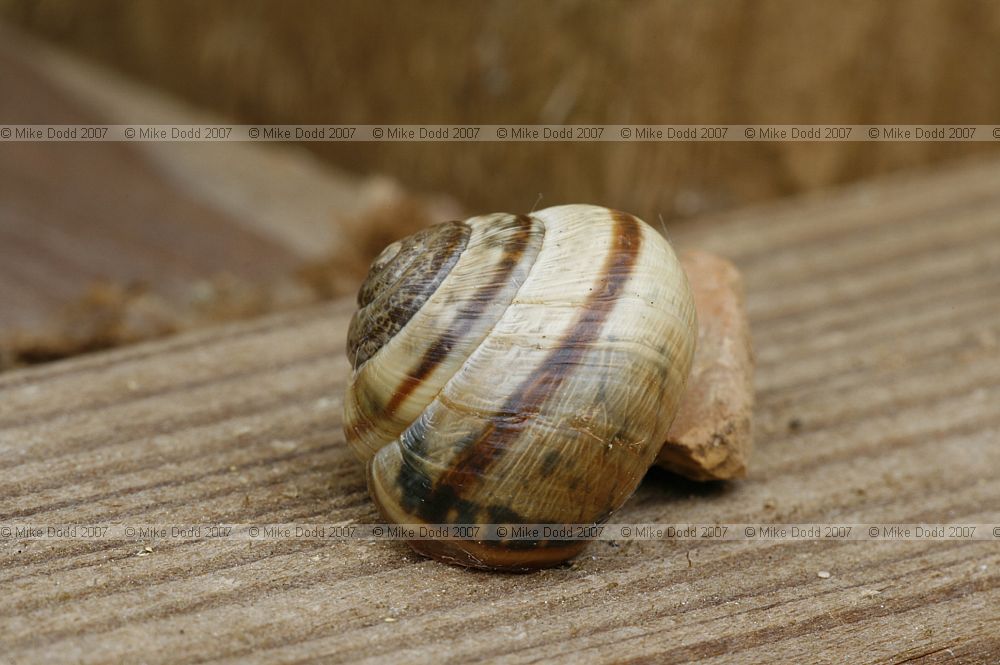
[347, 222, 472, 369]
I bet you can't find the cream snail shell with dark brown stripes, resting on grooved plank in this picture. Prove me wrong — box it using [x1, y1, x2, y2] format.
[344, 205, 697, 570]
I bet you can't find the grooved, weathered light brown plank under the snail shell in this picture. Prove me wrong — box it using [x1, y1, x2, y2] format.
[0, 157, 1000, 663]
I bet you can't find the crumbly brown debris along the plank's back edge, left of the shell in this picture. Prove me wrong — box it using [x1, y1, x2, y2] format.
[0, 192, 458, 371]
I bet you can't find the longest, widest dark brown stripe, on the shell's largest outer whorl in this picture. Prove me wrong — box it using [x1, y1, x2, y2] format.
[415, 211, 642, 523]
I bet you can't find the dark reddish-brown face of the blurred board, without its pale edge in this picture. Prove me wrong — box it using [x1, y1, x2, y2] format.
[0, 30, 295, 328]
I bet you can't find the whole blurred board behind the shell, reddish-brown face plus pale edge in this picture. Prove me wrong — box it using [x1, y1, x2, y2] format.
[0, 25, 458, 338]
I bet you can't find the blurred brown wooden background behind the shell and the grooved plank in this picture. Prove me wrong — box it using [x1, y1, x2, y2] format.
[0, 0, 1000, 366]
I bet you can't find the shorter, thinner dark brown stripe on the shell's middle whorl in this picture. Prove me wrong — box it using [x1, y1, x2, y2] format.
[385, 215, 543, 415]
